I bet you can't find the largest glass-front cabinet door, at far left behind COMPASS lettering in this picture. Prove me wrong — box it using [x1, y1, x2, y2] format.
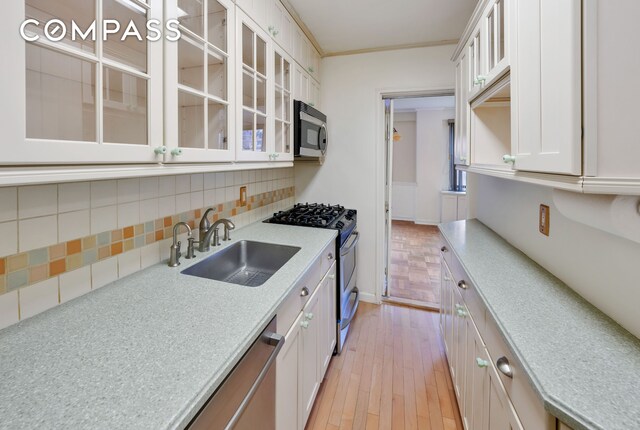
[0, 0, 163, 165]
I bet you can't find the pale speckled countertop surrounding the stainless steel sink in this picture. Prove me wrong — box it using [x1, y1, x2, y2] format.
[0, 223, 336, 429]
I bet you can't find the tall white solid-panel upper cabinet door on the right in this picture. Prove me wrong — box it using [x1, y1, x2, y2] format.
[511, 0, 582, 176]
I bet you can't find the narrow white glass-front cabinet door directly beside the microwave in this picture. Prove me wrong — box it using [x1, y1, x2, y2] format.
[269, 46, 293, 161]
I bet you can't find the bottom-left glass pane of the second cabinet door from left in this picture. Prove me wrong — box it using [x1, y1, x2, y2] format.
[178, 91, 205, 148]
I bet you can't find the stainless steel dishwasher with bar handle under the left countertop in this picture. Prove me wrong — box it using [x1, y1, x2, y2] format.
[189, 317, 284, 430]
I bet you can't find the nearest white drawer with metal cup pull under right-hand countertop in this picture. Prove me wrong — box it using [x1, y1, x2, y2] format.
[484, 316, 555, 429]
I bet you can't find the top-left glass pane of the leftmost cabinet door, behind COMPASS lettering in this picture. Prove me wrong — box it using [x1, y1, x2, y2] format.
[25, 0, 97, 52]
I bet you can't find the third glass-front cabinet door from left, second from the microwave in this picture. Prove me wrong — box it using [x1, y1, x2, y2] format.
[236, 9, 273, 161]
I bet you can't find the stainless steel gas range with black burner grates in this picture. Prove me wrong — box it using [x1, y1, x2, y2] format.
[265, 203, 360, 354]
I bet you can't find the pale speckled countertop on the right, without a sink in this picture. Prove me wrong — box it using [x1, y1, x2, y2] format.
[440, 220, 640, 430]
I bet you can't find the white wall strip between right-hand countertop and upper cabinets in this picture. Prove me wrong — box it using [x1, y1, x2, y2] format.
[470, 175, 640, 337]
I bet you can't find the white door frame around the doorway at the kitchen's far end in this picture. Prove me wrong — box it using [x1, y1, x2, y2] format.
[375, 85, 455, 304]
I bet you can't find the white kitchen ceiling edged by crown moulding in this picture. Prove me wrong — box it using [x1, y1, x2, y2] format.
[288, 0, 478, 55]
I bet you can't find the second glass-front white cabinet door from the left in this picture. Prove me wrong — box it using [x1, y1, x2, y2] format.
[165, 0, 235, 163]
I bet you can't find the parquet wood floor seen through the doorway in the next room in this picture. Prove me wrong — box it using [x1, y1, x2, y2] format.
[389, 221, 442, 308]
